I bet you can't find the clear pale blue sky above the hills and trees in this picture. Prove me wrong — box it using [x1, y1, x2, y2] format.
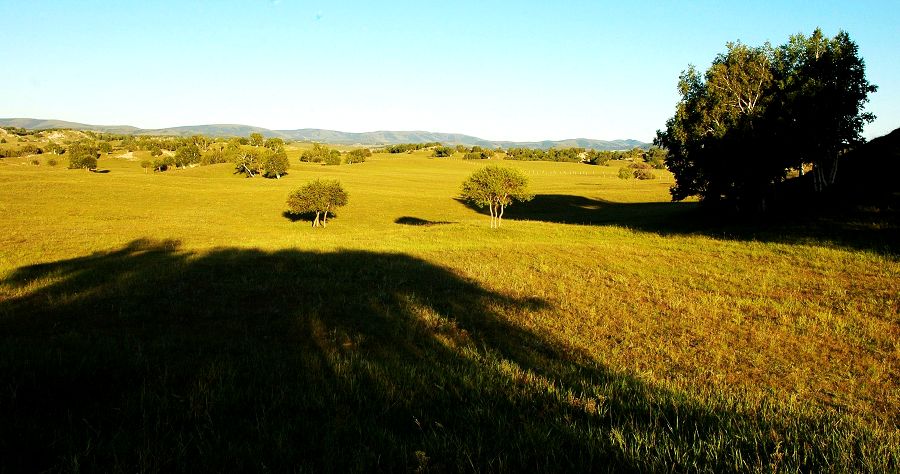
[0, 0, 900, 141]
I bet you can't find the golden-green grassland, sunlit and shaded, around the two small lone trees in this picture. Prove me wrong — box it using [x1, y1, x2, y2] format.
[0, 145, 900, 472]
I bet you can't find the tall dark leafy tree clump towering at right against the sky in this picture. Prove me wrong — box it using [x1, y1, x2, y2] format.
[655, 29, 876, 210]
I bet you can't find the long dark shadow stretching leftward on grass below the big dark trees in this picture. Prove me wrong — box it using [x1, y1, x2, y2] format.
[466, 194, 900, 255]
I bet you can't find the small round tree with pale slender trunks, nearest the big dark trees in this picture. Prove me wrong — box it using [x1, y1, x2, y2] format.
[461, 166, 534, 229]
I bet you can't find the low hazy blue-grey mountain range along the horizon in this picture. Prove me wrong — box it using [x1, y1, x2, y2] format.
[0, 118, 650, 150]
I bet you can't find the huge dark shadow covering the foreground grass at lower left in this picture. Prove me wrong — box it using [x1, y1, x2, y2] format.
[0, 241, 877, 472]
